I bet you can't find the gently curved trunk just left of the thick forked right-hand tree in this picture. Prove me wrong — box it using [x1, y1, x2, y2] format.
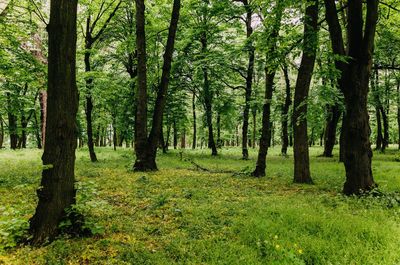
[293, 0, 318, 183]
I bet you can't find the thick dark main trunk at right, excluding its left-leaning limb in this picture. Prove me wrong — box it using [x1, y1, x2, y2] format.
[343, 0, 378, 195]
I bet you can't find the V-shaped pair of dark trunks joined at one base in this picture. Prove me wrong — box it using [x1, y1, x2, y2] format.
[134, 0, 181, 171]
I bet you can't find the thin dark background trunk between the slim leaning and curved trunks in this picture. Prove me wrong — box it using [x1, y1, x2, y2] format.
[281, 63, 292, 156]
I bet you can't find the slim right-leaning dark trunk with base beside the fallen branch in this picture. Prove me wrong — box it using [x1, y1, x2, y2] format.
[252, 1, 284, 177]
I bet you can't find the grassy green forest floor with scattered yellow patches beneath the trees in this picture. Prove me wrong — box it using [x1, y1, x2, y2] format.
[0, 147, 400, 265]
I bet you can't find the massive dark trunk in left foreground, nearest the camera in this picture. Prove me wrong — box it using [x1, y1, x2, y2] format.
[30, 0, 78, 245]
